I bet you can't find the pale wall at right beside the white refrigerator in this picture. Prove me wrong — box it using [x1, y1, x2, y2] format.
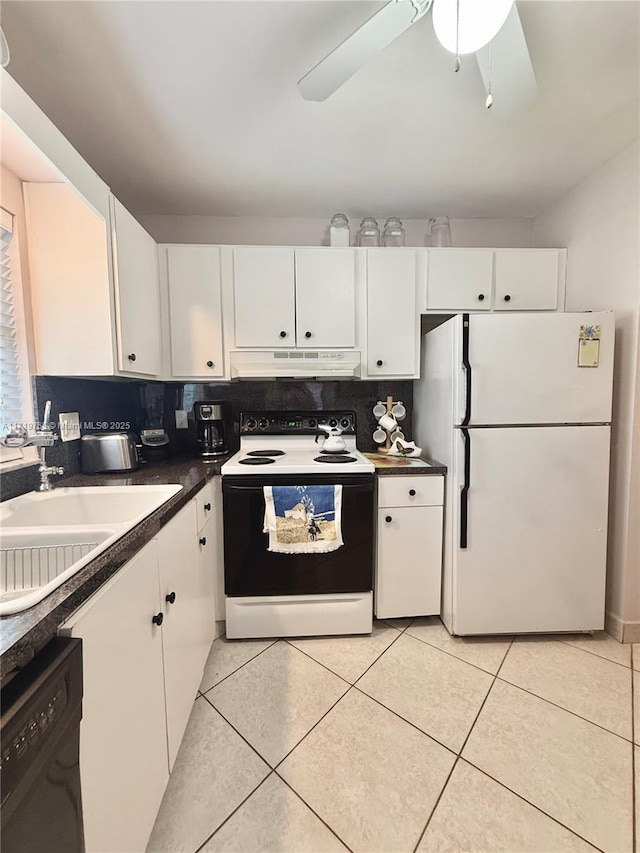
[532, 142, 640, 642]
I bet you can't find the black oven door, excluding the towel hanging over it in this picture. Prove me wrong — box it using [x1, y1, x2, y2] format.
[222, 474, 374, 597]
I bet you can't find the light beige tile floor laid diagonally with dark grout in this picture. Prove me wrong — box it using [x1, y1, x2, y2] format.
[148, 617, 640, 853]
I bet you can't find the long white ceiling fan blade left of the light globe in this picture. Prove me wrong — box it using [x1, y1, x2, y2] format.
[298, 0, 431, 101]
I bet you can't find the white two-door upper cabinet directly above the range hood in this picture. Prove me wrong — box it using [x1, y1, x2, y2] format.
[233, 247, 355, 349]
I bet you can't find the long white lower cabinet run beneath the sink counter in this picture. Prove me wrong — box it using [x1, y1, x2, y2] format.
[60, 486, 216, 853]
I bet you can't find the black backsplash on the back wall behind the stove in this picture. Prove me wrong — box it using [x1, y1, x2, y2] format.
[162, 380, 413, 452]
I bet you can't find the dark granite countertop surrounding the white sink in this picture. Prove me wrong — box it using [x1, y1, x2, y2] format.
[0, 456, 229, 684]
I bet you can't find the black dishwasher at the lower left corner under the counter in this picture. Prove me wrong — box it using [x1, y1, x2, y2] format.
[0, 637, 84, 853]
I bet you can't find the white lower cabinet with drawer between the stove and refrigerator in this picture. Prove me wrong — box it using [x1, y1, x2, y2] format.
[375, 475, 444, 619]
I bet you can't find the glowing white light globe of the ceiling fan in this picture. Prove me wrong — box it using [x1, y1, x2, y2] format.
[433, 0, 514, 56]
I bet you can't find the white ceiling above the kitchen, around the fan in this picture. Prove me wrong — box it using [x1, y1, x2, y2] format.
[2, 0, 640, 218]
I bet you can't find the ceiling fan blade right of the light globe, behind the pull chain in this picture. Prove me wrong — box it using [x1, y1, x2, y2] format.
[476, 3, 538, 116]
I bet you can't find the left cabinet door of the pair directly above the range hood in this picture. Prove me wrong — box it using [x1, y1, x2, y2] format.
[233, 247, 295, 348]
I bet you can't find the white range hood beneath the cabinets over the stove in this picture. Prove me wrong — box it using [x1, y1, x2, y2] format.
[229, 350, 360, 379]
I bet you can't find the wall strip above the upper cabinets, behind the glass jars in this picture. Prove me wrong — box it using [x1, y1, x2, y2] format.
[139, 215, 531, 247]
